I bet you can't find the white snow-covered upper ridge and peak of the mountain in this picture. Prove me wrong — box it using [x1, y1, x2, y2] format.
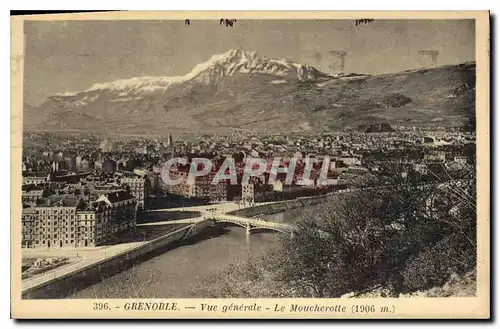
[64, 49, 327, 96]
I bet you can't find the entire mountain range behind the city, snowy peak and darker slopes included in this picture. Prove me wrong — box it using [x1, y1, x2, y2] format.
[24, 50, 475, 134]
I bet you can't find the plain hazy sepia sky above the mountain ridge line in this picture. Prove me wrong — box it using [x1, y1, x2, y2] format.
[24, 20, 475, 106]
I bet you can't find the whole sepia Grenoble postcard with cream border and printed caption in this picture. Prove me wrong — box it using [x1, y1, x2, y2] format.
[11, 11, 491, 319]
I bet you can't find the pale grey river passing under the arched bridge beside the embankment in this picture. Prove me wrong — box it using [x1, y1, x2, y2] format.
[69, 206, 322, 298]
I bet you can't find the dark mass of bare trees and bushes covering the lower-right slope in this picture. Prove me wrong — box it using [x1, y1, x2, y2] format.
[272, 158, 476, 297]
